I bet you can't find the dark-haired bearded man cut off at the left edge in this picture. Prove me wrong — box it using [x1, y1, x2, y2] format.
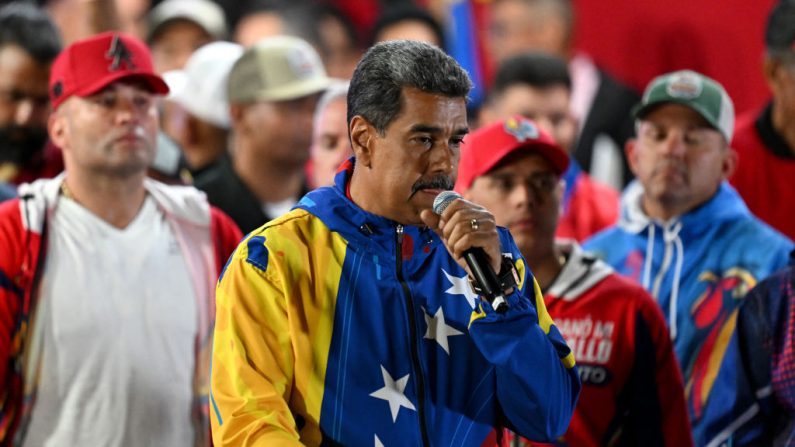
[0, 2, 63, 184]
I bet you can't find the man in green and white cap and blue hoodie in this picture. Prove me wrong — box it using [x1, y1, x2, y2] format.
[585, 70, 793, 446]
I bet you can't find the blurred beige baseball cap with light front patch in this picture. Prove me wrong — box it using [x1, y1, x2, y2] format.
[228, 36, 332, 103]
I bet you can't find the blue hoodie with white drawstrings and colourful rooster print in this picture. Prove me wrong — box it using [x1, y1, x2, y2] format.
[584, 181, 793, 446]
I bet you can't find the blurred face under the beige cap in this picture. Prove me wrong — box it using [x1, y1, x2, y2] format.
[236, 94, 320, 168]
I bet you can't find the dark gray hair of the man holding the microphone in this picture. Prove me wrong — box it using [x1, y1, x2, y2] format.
[348, 40, 472, 135]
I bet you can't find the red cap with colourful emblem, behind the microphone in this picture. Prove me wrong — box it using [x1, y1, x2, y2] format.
[455, 116, 569, 194]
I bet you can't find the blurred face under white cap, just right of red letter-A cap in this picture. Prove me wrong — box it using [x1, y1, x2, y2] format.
[150, 20, 213, 73]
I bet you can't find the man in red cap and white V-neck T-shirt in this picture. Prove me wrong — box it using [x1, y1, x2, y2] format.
[0, 33, 241, 446]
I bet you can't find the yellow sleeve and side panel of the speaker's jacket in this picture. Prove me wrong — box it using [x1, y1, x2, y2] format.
[211, 210, 346, 446]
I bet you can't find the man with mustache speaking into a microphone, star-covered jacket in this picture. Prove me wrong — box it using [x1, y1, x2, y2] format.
[210, 41, 580, 446]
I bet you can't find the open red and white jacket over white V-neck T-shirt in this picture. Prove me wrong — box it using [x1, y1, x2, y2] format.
[0, 174, 242, 446]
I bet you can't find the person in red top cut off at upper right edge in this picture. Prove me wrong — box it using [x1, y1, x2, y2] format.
[729, 0, 795, 239]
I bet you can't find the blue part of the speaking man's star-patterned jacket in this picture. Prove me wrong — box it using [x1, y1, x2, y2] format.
[296, 164, 580, 446]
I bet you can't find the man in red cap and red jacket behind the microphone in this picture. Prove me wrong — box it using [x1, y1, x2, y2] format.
[455, 116, 693, 447]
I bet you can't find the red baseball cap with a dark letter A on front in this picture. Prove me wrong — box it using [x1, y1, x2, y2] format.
[50, 31, 168, 110]
